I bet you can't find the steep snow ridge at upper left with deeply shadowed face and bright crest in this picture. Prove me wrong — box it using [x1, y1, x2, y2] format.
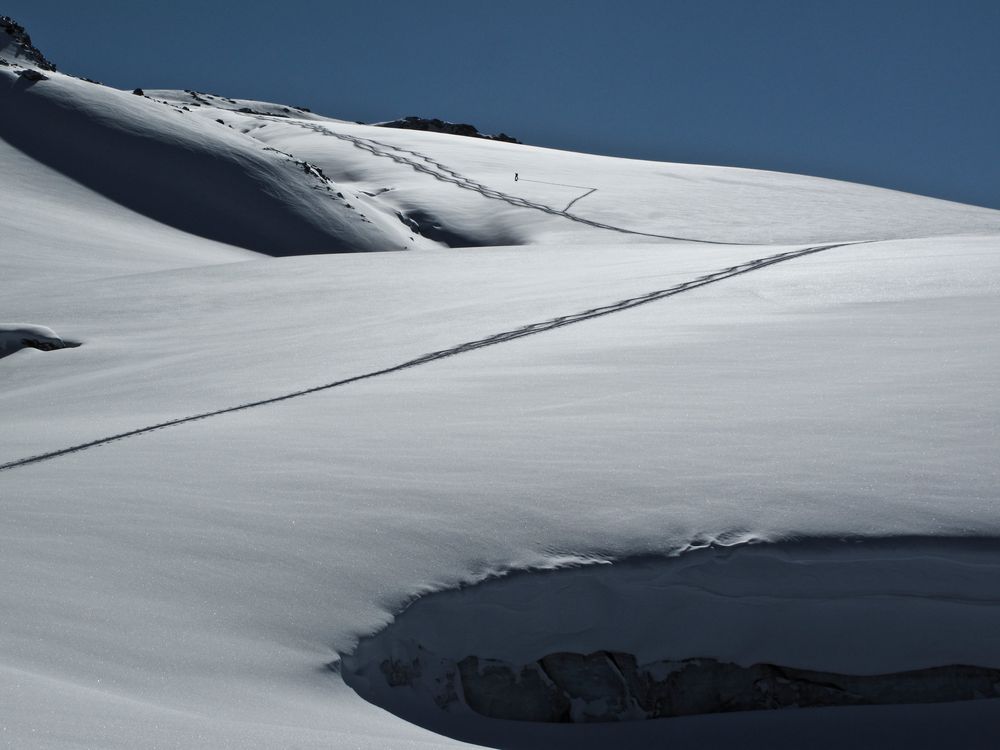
[0, 69, 430, 255]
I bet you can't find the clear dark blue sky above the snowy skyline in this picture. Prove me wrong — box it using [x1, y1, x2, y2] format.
[7, 0, 1000, 208]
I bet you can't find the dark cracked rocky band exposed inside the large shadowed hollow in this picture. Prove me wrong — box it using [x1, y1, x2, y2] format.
[380, 649, 1000, 723]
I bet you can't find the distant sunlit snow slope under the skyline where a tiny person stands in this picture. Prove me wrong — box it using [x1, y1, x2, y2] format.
[236, 108, 1000, 246]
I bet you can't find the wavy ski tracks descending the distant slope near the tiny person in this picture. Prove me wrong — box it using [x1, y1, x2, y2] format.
[270, 116, 757, 245]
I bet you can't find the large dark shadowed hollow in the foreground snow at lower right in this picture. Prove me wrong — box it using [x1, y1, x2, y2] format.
[339, 539, 1000, 748]
